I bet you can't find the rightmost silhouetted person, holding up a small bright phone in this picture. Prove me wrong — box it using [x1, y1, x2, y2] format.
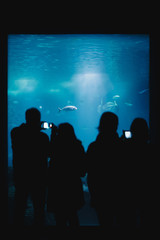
[126, 118, 153, 227]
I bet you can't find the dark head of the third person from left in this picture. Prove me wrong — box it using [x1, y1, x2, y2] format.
[98, 112, 118, 134]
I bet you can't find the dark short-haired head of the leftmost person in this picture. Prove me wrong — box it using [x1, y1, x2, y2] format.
[25, 108, 41, 129]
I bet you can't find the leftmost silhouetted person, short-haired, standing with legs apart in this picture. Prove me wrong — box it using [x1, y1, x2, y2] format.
[11, 108, 49, 225]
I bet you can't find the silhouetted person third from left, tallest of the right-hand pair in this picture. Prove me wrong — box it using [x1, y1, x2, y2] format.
[87, 112, 121, 228]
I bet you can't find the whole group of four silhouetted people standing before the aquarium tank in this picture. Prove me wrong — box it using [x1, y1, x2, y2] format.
[11, 108, 150, 227]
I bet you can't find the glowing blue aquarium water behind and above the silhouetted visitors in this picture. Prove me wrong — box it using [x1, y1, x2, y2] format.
[8, 34, 149, 166]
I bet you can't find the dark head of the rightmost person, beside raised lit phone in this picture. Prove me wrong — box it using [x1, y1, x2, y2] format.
[130, 118, 149, 143]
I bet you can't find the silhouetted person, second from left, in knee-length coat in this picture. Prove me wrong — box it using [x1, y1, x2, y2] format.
[47, 123, 85, 227]
